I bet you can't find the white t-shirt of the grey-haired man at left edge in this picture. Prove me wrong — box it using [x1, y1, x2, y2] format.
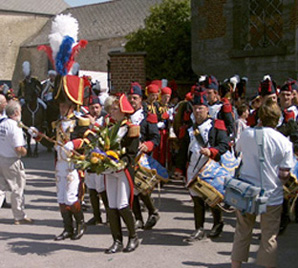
[0, 118, 26, 157]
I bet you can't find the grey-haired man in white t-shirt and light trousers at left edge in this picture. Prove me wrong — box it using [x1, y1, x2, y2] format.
[0, 100, 33, 225]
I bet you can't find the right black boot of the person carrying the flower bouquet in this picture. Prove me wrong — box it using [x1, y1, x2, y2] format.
[119, 207, 139, 252]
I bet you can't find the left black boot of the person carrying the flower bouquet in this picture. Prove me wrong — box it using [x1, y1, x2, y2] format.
[105, 208, 123, 254]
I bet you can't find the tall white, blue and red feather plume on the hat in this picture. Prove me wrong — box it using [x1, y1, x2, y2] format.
[38, 14, 88, 76]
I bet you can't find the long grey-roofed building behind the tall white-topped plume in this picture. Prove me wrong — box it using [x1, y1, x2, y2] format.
[13, 0, 162, 91]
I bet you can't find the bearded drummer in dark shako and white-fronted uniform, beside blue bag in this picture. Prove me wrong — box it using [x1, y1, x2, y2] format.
[174, 86, 229, 242]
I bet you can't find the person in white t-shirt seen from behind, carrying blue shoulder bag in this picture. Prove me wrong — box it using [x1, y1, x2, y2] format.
[232, 100, 293, 268]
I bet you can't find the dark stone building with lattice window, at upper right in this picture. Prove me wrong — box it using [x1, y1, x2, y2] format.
[192, 0, 298, 93]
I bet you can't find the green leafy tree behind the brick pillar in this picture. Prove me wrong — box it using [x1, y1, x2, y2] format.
[125, 0, 195, 80]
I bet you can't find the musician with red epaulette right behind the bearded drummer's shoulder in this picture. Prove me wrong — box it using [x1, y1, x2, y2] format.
[204, 75, 234, 136]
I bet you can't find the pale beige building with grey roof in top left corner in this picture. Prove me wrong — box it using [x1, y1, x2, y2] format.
[0, 0, 68, 87]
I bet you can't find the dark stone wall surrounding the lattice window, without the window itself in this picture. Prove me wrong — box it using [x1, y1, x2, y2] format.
[192, 0, 298, 95]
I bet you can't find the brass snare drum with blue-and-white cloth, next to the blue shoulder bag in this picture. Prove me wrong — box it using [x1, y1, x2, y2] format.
[186, 159, 230, 207]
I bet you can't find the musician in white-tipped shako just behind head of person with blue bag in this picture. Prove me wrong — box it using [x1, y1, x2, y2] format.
[247, 75, 277, 127]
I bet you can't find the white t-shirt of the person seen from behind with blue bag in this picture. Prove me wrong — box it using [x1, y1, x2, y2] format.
[236, 127, 294, 206]
